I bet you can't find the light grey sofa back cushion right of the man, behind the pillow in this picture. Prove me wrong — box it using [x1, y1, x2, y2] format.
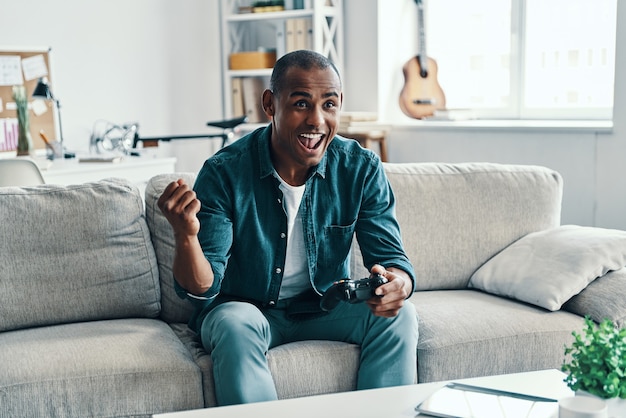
[385, 163, 562, 290]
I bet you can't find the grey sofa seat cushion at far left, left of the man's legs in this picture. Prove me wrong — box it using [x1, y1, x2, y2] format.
[0, 319, 204, 418]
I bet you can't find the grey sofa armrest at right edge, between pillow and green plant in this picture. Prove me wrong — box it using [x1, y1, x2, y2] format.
[562, 267, 626, 328]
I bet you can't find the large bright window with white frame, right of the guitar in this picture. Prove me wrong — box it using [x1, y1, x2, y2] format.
[424, 0, 617, 119]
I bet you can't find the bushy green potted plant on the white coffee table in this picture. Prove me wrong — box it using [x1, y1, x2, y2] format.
[561, 316, 626, 416]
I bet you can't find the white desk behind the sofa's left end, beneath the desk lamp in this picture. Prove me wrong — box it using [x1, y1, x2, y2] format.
[41, 157, 176, 195]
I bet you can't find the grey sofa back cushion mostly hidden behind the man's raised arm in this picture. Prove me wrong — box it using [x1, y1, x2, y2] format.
[145, 173, 196, 323]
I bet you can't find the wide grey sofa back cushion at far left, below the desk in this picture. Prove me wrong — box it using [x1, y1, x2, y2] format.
[0, 179, 160, 331]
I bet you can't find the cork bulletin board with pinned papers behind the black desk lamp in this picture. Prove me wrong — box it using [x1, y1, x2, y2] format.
[0, 47, 58, 152]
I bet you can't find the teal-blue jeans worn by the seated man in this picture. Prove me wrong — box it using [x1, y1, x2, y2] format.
[200, 301, 418, 405]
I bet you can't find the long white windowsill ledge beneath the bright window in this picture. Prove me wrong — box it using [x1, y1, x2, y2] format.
[391, 119, 613, 133]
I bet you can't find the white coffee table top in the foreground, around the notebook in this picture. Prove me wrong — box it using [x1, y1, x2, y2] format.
[154, 370, 573, 418]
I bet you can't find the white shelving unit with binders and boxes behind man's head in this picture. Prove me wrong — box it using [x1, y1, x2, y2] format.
[220, 0, 343, 122]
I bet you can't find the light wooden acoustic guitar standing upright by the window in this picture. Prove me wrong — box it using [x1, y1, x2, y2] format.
[400, 0, 446, 119]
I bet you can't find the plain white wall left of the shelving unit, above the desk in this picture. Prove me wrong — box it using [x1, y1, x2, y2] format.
[0, 0, 222, 171]
